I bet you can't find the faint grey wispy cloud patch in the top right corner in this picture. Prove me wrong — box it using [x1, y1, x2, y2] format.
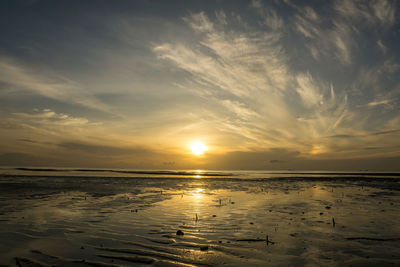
[289, 0, 396, 66]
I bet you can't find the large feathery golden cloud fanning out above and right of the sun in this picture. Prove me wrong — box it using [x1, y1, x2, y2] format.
[153, 10, 354, 157]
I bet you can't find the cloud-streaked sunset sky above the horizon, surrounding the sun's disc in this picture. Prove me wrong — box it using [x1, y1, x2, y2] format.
[0, 0, 400, 171]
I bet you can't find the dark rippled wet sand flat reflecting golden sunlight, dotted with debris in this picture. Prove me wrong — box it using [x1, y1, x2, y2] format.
[0, 175, 400, 266]
